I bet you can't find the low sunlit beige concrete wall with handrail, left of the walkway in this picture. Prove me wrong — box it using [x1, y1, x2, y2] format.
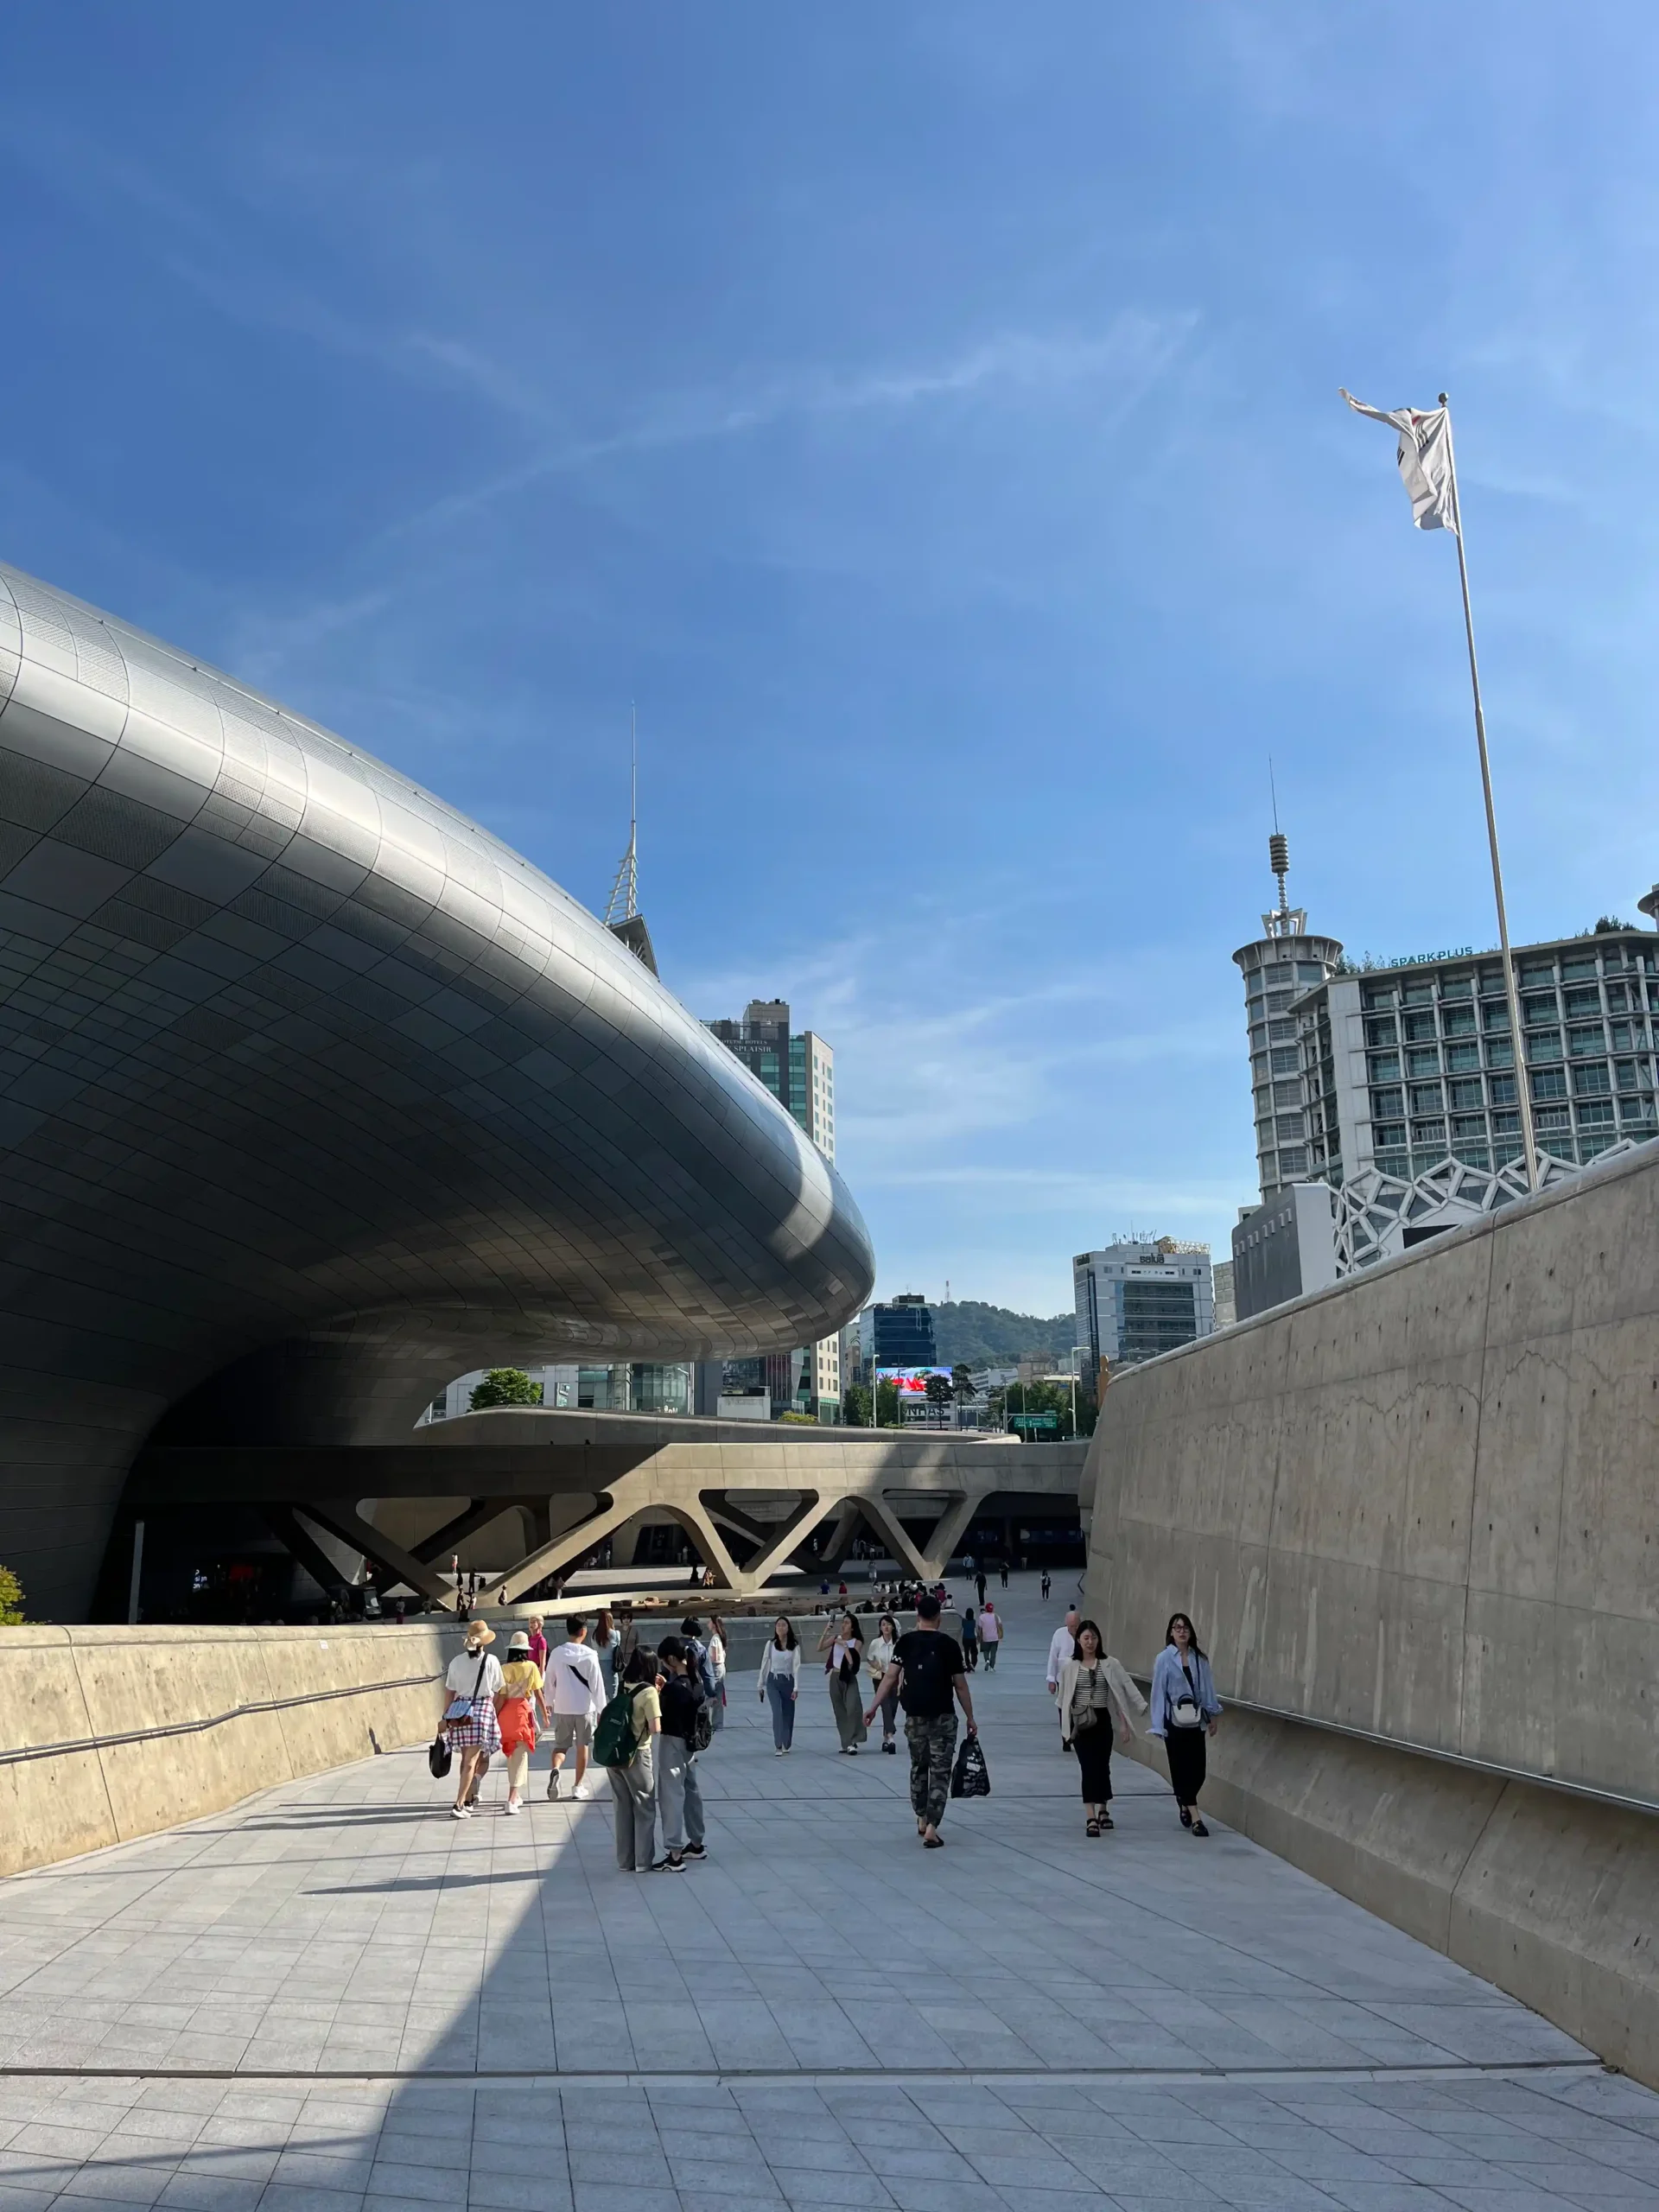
[0, 1624, 460, 1873]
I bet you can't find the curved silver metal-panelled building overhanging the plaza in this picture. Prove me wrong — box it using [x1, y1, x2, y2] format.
[0, 569, 874, 1619]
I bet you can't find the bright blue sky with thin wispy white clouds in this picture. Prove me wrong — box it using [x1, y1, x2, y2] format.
[0, 0, 1659, 1312]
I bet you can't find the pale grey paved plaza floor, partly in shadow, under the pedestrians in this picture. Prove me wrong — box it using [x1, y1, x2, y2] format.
[0, 1586, 1659, 2212]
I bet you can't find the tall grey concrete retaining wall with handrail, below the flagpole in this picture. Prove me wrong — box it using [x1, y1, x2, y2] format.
[1086, 1146, 1659, 2086]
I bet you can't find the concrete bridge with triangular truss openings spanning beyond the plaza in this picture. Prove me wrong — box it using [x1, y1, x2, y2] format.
[128, 1407, 1086, 1604]
